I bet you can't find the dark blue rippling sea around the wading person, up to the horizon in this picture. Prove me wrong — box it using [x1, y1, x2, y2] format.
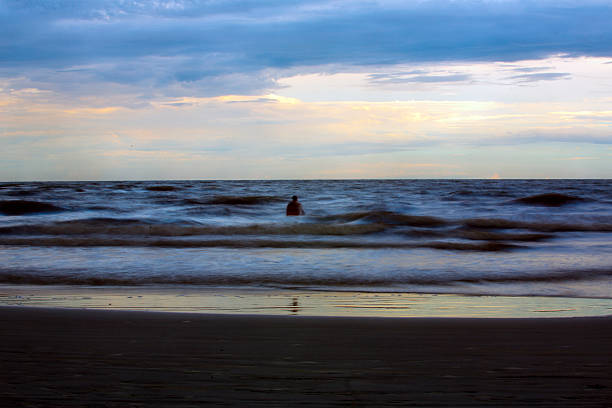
[0, 180, 612, 298]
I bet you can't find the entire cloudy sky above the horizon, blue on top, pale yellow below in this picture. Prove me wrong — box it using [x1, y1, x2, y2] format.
[0, 0, 612, 181]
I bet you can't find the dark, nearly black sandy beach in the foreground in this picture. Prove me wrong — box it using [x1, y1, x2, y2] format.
[0, 307, 612, 407]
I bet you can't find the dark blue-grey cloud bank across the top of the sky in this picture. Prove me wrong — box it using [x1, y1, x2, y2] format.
[0, 0, 612, 94]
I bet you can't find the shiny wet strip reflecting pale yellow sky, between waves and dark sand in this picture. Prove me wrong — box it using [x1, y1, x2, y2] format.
[0, 285, 612, 318]
